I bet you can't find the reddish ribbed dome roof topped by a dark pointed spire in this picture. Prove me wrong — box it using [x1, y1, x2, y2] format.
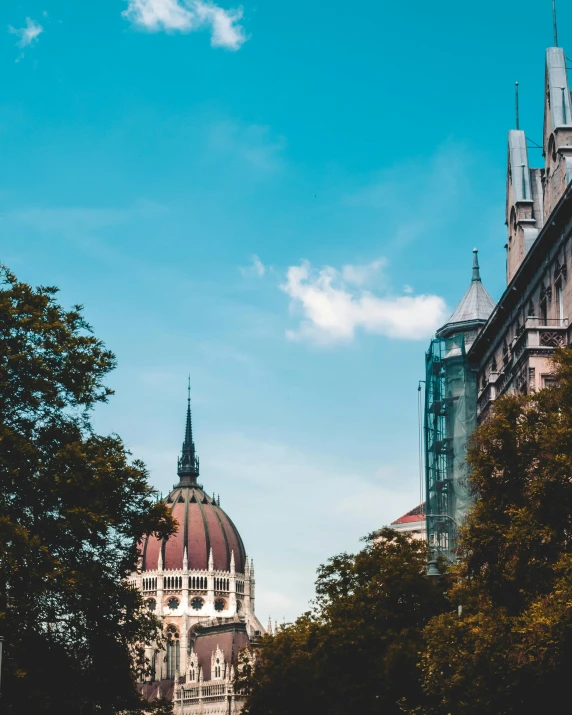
[141, 386, 246, 573]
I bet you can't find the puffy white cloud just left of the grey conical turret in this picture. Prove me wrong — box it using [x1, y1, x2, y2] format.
[281, 261, 447, 343]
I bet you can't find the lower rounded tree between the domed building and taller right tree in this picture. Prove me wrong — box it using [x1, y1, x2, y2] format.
[237, 529, 448, 715]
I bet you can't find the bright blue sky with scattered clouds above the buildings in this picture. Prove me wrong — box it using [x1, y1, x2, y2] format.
[0, 0, 572, 622]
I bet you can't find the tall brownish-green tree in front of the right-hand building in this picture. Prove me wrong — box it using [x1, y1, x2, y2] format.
[422, 349, 572, 715]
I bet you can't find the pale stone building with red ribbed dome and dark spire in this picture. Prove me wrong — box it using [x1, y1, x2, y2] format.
[131, 396, 265, 715]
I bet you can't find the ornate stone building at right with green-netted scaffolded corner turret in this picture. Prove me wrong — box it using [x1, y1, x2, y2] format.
[425, 40, 572, 559]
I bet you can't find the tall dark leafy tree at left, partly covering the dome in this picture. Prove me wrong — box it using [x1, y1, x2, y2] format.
[0, 267, 174, 715]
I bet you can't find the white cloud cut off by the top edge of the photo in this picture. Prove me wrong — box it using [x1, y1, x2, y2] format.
[123, 0, 247, 50]
